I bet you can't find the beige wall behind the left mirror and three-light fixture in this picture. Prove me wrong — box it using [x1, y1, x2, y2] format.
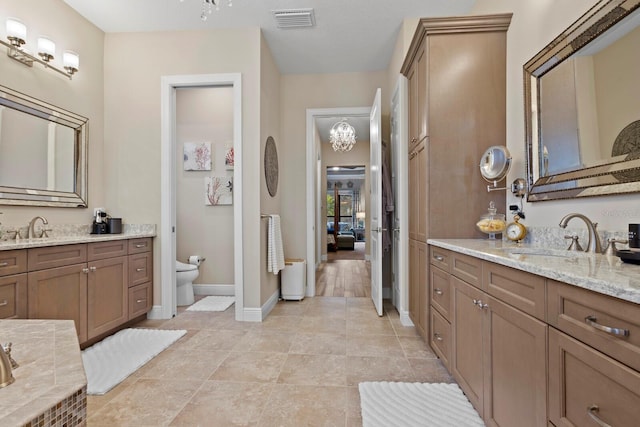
[0, 0, 104, 229]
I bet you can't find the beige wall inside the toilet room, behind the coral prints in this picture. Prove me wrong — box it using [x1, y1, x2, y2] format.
[176, 86, 234, 285]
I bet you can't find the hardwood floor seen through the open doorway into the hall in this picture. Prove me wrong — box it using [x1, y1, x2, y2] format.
[316, 259, 371, 297]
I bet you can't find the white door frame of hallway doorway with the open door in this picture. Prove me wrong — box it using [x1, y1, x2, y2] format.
[306, 107, 371, 297]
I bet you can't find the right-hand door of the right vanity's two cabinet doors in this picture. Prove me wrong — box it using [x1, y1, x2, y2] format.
[483, 297, 547, 427]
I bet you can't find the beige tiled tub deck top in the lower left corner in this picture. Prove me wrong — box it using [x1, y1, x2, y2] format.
[0, 319, 87, 426]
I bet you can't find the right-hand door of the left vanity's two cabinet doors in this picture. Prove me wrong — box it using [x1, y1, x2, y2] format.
[87, 256, 129, 339]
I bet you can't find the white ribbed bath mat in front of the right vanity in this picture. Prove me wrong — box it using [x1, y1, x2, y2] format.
[358, 382, 484, 427]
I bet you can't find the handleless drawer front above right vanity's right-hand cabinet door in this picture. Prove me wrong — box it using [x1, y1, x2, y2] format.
[483, 262, 545, 320]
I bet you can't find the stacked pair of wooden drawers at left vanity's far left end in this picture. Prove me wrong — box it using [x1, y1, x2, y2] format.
[0, 249, 27, 319]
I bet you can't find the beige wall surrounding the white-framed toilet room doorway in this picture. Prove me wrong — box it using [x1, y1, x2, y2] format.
[104, 28, 260, 307]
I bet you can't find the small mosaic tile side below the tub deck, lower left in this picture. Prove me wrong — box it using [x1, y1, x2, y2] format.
[23, 386, 87, 427]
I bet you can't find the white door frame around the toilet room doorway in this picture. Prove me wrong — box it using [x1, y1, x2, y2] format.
[159, 73, 244, 320]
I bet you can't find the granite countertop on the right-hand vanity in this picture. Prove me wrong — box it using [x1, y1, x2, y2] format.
[427, 239, 640, 304]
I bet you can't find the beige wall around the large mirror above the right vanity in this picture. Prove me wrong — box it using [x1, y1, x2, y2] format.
[471, 0, 640, 231]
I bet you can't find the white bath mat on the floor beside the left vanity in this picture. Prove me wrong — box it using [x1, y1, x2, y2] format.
[82, 328, 187, 395]
